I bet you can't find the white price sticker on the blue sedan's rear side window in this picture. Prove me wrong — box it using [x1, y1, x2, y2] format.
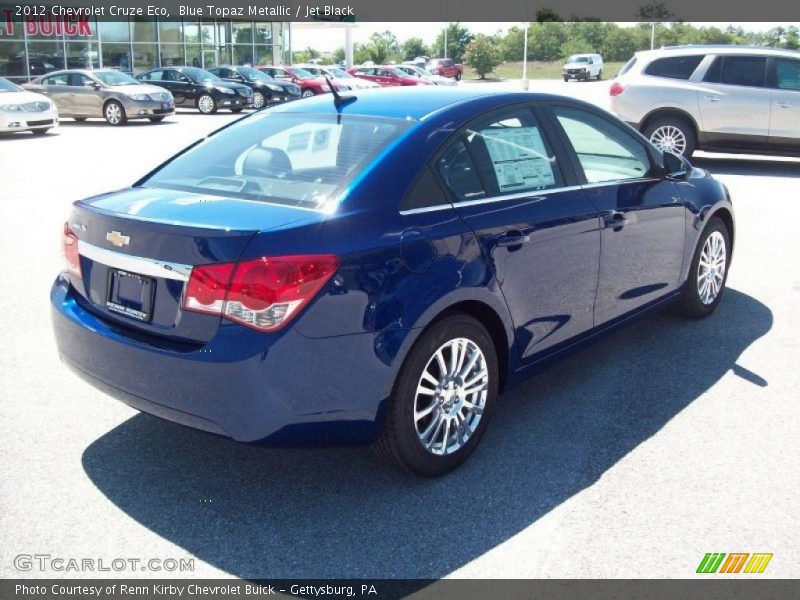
[479, 127, 555, 192]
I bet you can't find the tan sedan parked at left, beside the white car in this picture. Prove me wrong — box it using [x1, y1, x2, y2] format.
[23, 69, 175, 125]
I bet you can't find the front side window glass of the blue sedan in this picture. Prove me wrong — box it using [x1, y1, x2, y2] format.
[553, 106, 655, 183]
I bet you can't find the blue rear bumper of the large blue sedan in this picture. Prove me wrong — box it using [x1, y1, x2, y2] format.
[51, 277, 394, 444]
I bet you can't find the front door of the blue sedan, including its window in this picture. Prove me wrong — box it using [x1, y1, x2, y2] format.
[547, 103, 686, 325]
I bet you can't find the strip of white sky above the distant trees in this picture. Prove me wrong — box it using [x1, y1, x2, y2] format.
[292, 22, 798, 52]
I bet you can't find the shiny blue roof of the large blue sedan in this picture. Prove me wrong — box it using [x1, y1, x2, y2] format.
[269, 86, 583, 120]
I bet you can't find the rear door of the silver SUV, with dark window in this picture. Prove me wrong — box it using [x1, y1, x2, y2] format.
[698, 55, 772, 146]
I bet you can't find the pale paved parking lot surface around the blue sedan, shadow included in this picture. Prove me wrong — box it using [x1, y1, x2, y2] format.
[0, 81, 800, 578]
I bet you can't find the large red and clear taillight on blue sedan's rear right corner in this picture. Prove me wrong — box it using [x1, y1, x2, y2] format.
[183, 254, 339, 331]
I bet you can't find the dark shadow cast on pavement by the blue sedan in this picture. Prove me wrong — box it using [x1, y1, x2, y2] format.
[83, 289, 773, 578]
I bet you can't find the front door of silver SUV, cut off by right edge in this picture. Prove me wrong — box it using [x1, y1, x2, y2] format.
[769, 58, 800, 149]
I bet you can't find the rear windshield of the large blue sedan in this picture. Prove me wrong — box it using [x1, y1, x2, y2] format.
[139, 113, 409, 211]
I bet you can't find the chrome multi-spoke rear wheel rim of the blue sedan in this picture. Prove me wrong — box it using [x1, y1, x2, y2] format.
[414, 338, 489, 456]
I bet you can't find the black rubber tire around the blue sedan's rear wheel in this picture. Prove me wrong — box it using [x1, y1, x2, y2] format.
[374, 313, 499, 477]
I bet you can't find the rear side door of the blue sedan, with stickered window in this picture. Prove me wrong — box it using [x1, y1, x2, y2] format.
[434, 105, 600, 360]
